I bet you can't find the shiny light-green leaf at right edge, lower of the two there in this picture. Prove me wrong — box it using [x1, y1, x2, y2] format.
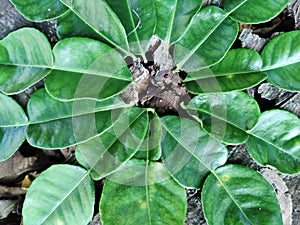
[247, 110, 300, 174]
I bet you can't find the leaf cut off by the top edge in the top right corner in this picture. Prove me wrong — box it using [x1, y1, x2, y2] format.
[223, 0, 290, 24]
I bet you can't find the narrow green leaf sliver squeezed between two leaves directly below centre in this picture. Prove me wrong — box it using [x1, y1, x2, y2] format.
[134, 113, 162, 161]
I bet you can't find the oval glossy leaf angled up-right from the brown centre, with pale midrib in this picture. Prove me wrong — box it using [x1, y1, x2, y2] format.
[174, 6, 238, 72]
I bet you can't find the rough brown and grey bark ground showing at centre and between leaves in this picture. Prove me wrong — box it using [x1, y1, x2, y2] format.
[0, 0, 300, 225]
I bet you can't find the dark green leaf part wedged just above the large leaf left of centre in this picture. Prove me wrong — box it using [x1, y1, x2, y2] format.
[56, 11, 101, 41]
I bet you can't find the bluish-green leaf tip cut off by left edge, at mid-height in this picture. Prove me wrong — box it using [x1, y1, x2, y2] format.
[0, 94, 28, 162]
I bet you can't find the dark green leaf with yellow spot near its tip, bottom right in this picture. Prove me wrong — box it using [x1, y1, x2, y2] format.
[201, 165, 283, 225]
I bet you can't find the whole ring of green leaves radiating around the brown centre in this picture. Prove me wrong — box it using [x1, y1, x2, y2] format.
[0, 0, 300, 225]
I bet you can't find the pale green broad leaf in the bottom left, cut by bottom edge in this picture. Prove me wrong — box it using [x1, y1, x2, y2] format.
[22, 165, 95, 225]
